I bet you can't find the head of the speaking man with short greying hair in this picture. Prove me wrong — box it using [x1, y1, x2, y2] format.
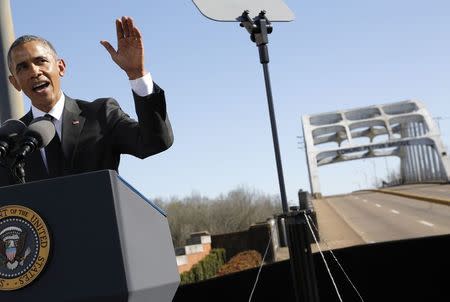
[9, 41, 66, 112]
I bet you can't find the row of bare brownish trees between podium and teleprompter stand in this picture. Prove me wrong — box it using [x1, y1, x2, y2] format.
[154, 186, 281, 246]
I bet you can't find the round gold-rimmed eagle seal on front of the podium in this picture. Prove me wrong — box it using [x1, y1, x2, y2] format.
[0, 205, 50, 291]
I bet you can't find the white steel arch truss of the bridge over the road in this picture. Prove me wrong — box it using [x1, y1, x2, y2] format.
[302, 100, 450, 196]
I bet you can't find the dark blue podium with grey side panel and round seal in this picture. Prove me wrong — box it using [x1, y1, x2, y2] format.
[0, 170, 180, 302]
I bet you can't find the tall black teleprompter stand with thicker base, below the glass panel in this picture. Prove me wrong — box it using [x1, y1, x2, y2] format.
[239, 10, 319, 302]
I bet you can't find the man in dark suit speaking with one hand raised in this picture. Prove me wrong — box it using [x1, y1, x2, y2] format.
[0, 17, 173, 186]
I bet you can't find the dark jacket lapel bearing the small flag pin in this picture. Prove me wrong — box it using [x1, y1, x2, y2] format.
[61, 96, 85, 169]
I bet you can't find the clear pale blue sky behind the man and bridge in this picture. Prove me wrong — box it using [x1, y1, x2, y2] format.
[7, 0, 450, 202]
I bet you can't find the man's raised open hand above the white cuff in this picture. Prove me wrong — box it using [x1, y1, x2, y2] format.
[100, 16, 147, 80]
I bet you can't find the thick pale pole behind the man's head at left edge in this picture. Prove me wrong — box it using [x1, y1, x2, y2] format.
[0, 0, 24, 123]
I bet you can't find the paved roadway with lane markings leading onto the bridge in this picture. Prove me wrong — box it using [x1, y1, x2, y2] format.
[314, 184, 450, 249]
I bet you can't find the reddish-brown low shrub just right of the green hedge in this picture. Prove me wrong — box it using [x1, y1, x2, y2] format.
[180, 249, 226, 285]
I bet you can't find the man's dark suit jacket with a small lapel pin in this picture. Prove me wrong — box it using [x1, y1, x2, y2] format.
[0, 84, 173, 186]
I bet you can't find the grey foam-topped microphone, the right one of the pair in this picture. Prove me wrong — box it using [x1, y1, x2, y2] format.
[16, 117, 56, 162]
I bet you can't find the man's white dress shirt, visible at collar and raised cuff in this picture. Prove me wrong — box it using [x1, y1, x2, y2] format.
[31, 73, 153, 171]
